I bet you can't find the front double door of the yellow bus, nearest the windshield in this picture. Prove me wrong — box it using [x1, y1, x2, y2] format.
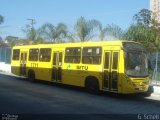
[103, 51, 119, 92]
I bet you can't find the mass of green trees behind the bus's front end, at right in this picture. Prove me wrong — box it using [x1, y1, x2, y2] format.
[104, 9, 160, 51]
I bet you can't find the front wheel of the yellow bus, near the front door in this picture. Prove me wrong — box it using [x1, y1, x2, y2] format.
[85, 77, 99, 94]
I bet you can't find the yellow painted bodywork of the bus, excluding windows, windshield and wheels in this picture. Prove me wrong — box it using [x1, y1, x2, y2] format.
[11, 41, 149, 94]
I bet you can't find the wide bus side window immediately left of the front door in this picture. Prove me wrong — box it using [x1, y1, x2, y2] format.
[82, 47, 102, 64]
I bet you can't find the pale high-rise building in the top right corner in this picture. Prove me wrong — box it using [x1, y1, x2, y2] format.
[150, 0, 160, 23]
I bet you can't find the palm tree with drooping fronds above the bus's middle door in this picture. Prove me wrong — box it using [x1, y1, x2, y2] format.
[39, 23, 68, 43]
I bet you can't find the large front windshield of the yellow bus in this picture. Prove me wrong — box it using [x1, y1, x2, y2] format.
[123, 43, 148, 77]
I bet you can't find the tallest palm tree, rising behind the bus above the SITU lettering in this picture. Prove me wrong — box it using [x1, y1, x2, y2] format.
[74, 17, 100, 42]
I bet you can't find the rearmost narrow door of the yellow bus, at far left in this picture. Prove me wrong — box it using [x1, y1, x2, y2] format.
[20, 52, 27, 76]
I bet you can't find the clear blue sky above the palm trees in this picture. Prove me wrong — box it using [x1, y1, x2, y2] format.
[0, 0, 149, 39]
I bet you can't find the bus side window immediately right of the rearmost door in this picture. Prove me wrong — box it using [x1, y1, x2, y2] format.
[29, 49, 39, 61]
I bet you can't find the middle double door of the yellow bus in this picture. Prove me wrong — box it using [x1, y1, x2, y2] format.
[52, 52, 62, 82]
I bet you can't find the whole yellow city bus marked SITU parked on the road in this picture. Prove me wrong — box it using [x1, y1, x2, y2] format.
[11, 40, 149, 94]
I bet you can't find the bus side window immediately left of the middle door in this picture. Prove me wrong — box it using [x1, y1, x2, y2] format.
[39, 48, 51, 62]
